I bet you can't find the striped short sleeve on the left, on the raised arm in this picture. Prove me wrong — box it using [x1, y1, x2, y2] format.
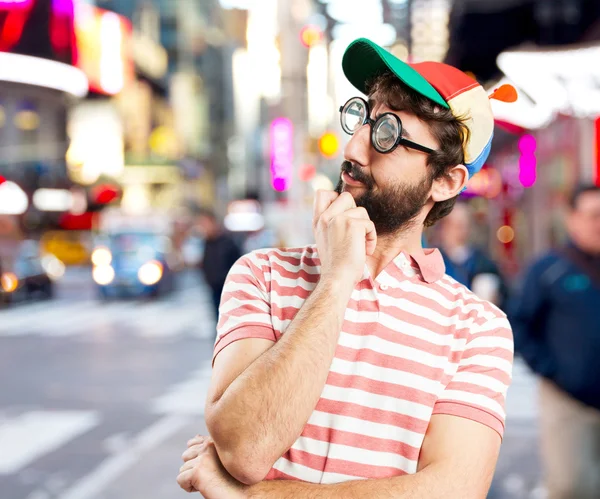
[213, 252, 276, 362]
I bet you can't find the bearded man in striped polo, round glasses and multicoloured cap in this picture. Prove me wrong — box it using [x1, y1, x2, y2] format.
[178, 39, 512, 499]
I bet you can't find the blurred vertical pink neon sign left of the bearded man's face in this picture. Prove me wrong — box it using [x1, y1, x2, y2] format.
[269, 118, 294, 191]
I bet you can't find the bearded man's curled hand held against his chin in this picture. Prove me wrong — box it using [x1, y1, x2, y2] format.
[313, 191, 377, 284]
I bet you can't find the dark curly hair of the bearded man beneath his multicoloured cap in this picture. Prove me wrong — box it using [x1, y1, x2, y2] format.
[367, 72, 469, 227]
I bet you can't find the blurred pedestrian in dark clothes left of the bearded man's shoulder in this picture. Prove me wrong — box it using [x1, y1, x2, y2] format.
[196, 208, 242, 321]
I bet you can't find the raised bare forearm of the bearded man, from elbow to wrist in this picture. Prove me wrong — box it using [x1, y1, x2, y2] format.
[209, 281, 351, 479]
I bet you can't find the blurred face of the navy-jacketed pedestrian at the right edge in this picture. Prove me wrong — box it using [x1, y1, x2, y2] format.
[567, 191, 600, 254]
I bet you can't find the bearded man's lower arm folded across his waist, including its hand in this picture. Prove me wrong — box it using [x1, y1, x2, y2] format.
[179, 415, 500, 499]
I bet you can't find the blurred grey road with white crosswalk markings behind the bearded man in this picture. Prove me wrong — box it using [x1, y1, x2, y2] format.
[0, 269, 545, 499]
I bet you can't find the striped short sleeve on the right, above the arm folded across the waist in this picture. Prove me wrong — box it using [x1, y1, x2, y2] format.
[433, 317, 514, 437]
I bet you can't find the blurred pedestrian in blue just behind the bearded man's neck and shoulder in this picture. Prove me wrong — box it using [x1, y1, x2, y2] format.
[440, 203, 507, 308]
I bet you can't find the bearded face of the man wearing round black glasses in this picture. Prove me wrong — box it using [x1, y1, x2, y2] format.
[336, 102, 438, 235]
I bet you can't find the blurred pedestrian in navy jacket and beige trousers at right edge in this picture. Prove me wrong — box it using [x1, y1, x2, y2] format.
[510, 185, 600, 499]
